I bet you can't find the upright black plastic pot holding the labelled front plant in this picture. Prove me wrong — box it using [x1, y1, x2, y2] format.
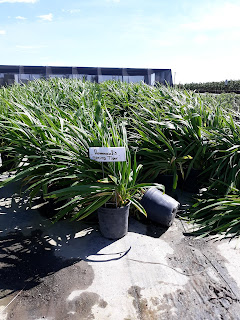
[98, 204, 130, 239]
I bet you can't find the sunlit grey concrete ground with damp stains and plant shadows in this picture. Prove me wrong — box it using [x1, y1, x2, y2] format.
[0, 176, 240, 320]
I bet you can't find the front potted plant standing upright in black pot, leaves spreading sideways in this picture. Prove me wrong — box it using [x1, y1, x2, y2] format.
[48, 150, 164, 239]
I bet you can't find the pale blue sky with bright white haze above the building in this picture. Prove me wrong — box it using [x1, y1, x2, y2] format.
[0, 0, 240, 83]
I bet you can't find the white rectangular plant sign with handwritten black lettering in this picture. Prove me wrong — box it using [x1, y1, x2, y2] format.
[89, 147, 126, 162]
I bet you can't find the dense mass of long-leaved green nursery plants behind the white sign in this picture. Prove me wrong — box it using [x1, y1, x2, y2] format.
[0, 79, 240, 237]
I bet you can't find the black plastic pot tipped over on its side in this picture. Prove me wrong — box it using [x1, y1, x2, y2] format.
[141, 188, 180, 227]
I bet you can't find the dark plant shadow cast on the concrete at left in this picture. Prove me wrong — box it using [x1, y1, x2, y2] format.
[0, 184, 130, 298]
